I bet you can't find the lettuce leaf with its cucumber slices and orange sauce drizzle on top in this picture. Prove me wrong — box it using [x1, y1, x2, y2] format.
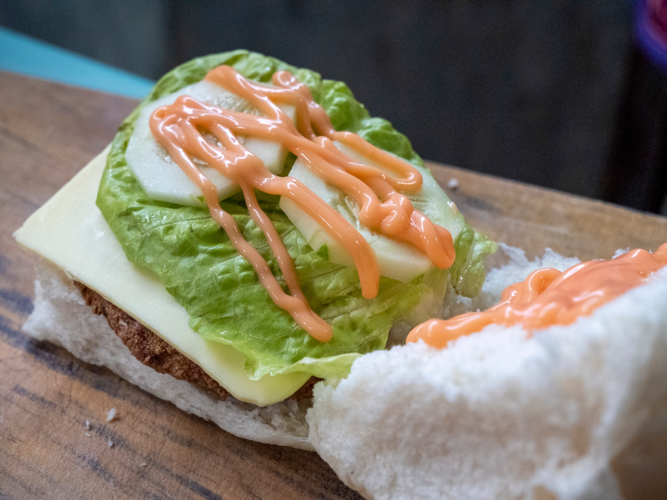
[97, 51, 495, 386]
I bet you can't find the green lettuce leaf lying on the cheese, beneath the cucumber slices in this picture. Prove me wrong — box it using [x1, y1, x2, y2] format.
[97, 51, 492, 379]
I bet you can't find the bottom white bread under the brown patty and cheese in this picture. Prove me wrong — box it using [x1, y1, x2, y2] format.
[23, 259, 312, 450]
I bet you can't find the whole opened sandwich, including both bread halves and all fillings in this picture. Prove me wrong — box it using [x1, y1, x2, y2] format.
[15, 51, 667, 499]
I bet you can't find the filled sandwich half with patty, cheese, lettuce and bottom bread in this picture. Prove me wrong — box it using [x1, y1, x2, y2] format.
[15, 51, 495, 449]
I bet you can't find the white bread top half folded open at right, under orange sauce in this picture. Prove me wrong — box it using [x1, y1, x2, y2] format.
[308, 247, 667, 500]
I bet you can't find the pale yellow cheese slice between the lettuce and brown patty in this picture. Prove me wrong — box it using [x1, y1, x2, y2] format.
[14, 148, 309, 406]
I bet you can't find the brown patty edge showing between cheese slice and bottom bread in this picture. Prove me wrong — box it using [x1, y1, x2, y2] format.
[74, 281, 317, 401]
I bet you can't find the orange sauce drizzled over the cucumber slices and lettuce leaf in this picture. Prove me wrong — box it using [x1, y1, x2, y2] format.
[150, 66, 455, 342]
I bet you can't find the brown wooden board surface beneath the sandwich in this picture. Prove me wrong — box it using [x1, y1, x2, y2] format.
[0, 73, 667, 499]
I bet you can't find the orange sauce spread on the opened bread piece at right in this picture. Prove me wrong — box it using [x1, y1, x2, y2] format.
[407, 243, 667, 349]
